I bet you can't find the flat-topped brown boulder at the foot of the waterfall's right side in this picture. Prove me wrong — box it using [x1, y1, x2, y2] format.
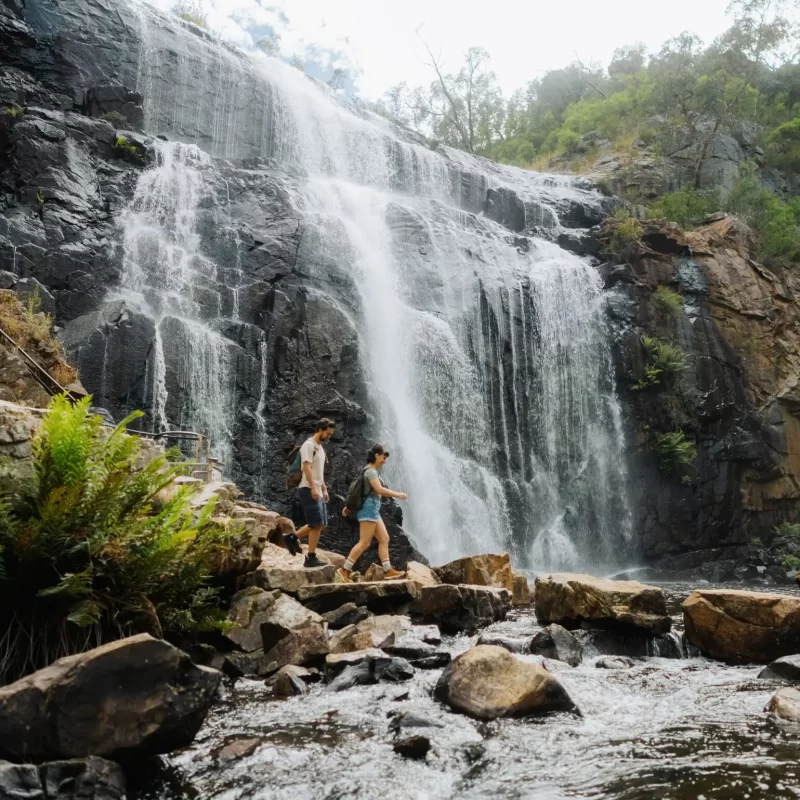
[534, 572, 672, 635]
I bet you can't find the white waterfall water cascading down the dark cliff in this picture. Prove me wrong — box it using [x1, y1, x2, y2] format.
[119, 1, 631, 568]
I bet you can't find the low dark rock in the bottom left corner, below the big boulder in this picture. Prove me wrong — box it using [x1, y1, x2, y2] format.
[0, 756, 125, 800]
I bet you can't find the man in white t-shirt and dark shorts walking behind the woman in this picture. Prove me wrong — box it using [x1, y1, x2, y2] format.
[283, 417, 334, 567]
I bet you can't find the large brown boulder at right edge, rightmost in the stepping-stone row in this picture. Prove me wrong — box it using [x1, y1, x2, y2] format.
[683, 589, 800, 663]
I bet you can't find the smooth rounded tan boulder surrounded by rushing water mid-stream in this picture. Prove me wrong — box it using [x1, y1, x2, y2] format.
[435, 645, 575, 719]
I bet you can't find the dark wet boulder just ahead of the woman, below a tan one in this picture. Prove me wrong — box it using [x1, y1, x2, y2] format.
[411, 583, 511, 633]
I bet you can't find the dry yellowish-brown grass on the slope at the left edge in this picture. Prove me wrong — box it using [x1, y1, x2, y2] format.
[0, 289, 78, 386]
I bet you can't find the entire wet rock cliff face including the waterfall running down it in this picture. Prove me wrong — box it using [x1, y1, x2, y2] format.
[0, 0, 798, 569]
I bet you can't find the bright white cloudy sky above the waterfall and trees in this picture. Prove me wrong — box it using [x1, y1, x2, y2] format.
[150, 0, 740, 99]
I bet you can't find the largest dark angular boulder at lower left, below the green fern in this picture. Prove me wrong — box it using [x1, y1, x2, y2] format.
[0, 634, 222, 761]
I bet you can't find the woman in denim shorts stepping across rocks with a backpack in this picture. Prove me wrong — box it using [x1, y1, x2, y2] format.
[336, 444, 408, 583]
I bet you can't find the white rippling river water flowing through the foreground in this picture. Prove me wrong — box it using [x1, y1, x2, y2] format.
[122, 584, 800, 800]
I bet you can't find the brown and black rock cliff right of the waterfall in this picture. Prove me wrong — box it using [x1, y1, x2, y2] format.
[604, 216, 800, 569]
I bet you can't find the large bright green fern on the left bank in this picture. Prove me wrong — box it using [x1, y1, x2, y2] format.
[0, 395, 234, 680]
